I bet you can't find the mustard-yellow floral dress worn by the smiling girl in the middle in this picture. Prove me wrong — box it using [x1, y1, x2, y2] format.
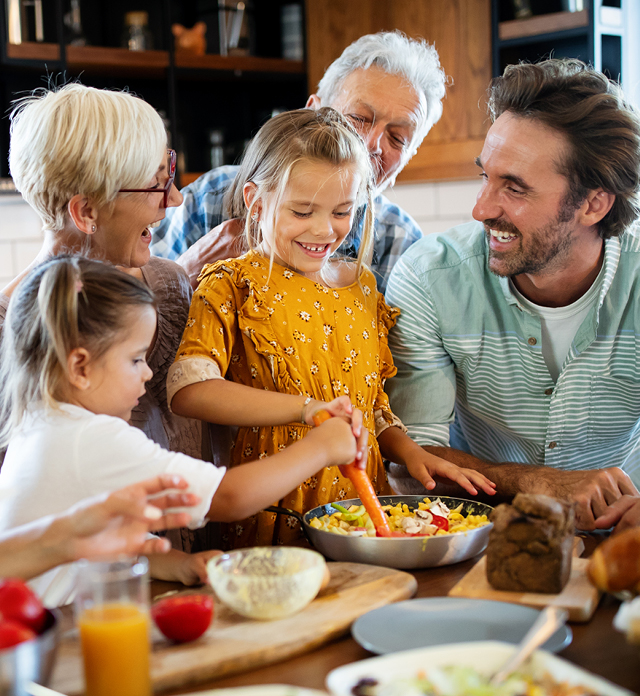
[174, 251, 399, 548]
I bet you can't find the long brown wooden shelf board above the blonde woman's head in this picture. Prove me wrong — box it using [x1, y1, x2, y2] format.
[7, 42, 306, 75]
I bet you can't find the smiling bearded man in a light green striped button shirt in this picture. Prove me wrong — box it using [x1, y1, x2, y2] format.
[387, 60, 640, 529]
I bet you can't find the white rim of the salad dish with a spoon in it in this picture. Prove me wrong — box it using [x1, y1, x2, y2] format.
[326, 641, 633, 696]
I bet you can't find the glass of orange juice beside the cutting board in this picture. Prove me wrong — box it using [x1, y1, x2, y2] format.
[75, 558, 151, 696]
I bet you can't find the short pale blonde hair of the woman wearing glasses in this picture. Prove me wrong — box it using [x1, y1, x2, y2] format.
[9, 83, 167, 232]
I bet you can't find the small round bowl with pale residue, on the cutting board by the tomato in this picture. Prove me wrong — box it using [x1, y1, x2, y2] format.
[207, 546, 325, 619]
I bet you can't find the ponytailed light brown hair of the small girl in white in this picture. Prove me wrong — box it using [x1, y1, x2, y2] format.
[0, 256, 156, 447]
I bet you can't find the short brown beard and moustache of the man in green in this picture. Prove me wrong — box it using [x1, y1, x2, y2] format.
[483, 203, 576, 276]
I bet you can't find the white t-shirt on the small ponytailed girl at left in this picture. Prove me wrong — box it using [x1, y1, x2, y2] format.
[0, 404, 225, 607]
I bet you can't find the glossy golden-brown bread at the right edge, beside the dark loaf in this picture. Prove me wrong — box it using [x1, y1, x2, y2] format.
[588, 527, 640, 593]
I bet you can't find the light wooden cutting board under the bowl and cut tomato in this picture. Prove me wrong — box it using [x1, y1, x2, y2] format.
[51, 563, 418, 696]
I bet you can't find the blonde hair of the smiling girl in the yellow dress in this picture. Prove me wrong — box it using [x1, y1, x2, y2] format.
[225, 107, 375, 278]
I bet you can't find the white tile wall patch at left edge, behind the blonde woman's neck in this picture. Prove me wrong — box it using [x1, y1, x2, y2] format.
[0, 194, 43, 288]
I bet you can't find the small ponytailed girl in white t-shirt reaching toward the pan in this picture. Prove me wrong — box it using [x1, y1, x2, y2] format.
[0, 257, 366, 606]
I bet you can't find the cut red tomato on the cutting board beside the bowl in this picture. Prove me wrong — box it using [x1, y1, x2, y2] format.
[151, 594, 213, 643]
